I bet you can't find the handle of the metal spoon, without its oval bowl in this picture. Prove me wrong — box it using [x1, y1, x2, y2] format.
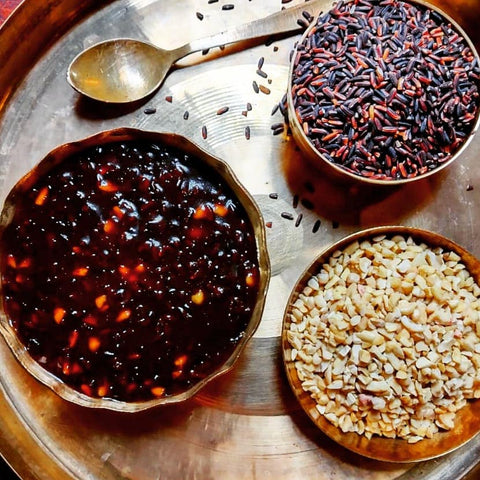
[172, 0, 326, 60]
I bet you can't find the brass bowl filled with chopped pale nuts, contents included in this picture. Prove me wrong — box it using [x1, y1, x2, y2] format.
[282, 226, 480, 462]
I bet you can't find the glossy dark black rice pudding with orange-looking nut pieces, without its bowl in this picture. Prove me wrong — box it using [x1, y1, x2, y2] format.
[0, 141, 259, 402]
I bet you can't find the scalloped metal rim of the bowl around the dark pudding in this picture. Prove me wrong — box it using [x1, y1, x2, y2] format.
[0, 128, 270, 412]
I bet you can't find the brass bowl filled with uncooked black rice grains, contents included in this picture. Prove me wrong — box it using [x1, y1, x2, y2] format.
[287, 0, 480, 185]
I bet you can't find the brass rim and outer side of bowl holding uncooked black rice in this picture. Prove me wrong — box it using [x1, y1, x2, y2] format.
[287, 0, 480, 186]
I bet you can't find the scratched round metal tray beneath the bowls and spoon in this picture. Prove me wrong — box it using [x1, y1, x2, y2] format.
[0, 0, 480, 480]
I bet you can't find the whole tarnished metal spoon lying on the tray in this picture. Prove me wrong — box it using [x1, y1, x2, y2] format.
[67, 0, 322, 103]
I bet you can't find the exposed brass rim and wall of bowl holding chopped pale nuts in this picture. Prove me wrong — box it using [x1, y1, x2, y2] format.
[281, 226, 480, 463]
